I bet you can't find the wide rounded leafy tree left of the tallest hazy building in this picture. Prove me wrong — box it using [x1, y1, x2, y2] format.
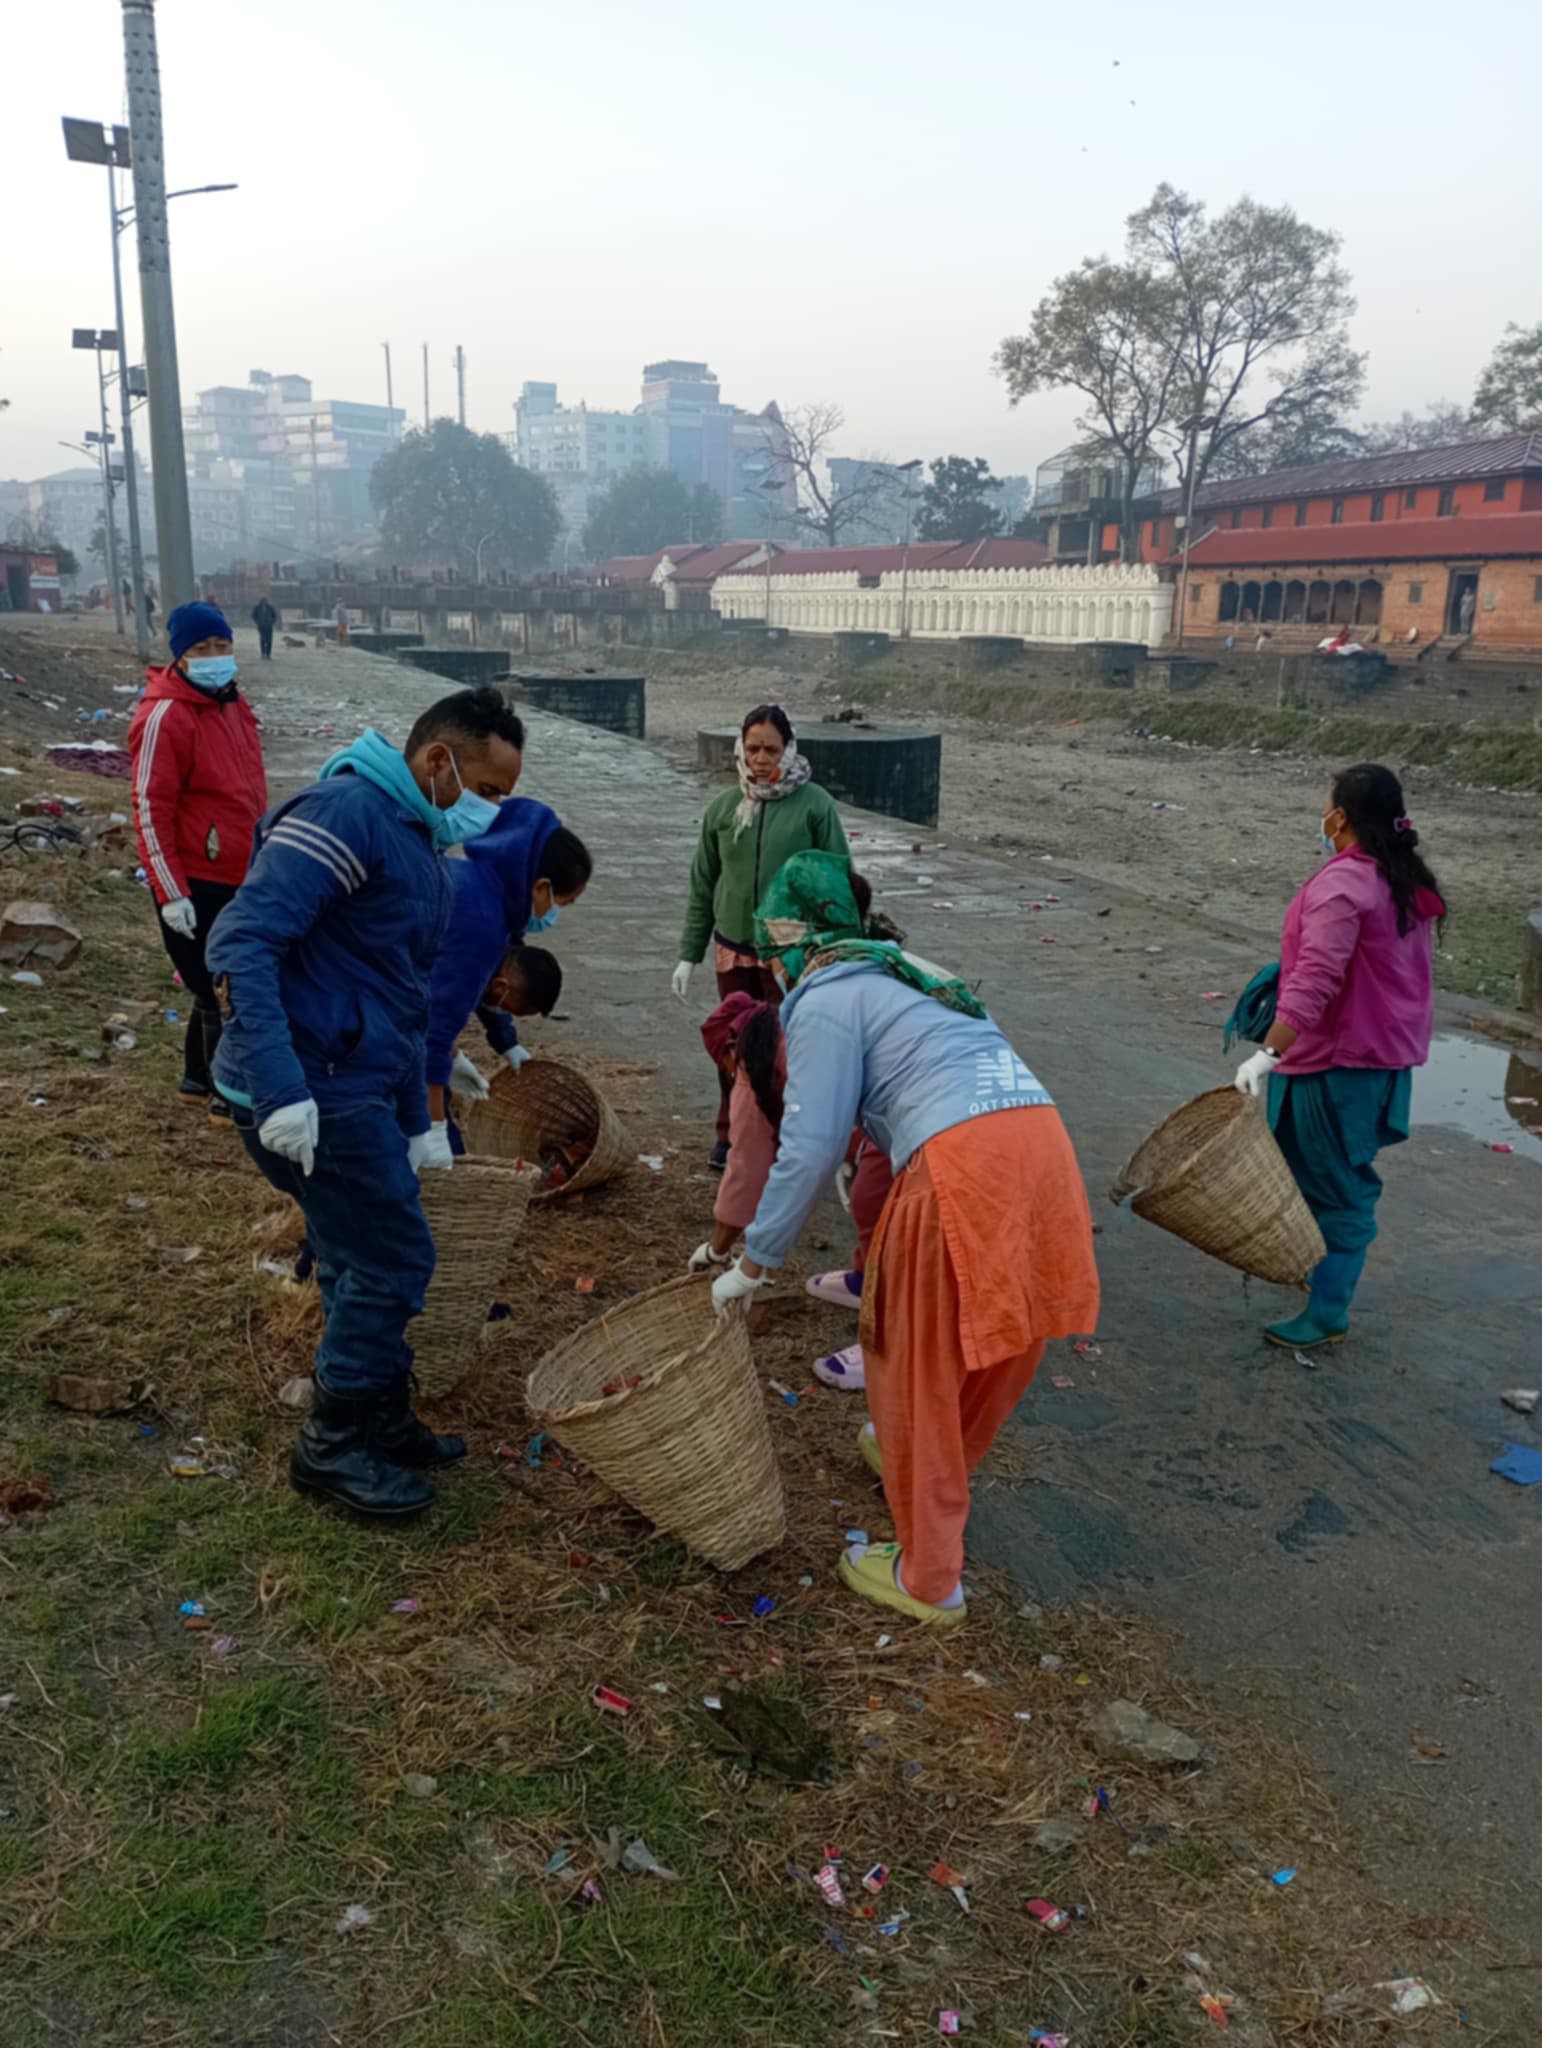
[369, 420, 561, 575]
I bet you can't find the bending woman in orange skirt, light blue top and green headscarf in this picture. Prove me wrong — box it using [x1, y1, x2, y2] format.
[713, 854, 1098, 1626]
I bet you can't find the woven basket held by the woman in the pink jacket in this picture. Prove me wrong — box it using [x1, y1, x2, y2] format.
[1108, 1087, 1327, 1286]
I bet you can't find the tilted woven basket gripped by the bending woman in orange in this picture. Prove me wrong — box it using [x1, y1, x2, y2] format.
[524, 1278, 786, 1571]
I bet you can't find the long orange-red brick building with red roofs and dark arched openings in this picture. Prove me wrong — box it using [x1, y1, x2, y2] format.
[1141, 432, 1542, 651]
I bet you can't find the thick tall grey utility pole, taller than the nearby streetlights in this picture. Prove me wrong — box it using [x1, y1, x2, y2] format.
[123, 0, 199, 612]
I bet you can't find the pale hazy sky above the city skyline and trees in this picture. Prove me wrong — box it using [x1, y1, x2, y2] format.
[0, 0, 1542, 477]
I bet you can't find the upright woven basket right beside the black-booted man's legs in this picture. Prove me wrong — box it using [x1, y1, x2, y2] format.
[408, 1157, 541, 1401]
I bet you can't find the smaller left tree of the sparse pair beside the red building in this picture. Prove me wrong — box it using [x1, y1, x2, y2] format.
[995, 256, 1180, 561]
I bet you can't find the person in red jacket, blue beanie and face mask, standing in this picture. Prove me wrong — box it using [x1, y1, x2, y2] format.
[129, 604, 268, 1114]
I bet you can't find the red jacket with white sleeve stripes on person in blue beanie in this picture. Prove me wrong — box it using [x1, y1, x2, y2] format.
[129, 668, 268, 903]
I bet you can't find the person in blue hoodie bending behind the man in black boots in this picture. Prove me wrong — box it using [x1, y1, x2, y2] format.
[426, 797, 594, 1165]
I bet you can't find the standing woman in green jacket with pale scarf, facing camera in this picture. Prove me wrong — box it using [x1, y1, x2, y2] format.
[672, 705, 850, 1174]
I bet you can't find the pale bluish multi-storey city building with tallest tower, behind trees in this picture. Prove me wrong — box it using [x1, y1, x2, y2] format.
[504, 360, 793, 551]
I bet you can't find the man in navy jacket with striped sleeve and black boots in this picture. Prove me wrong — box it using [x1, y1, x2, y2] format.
[209, 688, 524, 1516]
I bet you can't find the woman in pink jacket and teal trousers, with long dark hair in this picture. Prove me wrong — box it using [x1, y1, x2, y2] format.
[1237, 762, 1446, 1350]
